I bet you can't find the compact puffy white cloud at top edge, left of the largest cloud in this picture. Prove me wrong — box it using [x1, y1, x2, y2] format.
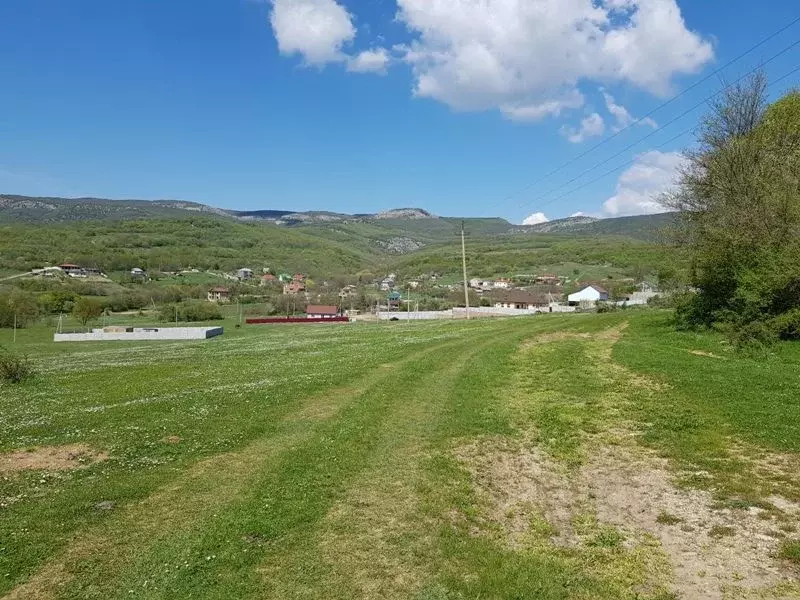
[270, 0, 356, 66]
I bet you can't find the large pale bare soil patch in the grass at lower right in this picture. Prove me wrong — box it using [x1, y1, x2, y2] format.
[456, 439, 800, 600]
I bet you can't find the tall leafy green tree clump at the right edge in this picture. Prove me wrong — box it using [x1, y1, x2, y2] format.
[666, 74, 800, 342]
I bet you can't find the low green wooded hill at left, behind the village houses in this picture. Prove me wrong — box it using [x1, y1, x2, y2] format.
[0, 216, 375, 273]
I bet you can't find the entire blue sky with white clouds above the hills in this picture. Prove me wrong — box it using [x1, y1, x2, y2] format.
[0, 0, 800, 222]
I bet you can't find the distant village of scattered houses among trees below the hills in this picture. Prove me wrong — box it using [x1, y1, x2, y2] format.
[7, 263, 661, 320]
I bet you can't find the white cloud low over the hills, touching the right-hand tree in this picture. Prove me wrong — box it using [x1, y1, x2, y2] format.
[602, 150, 686, 217]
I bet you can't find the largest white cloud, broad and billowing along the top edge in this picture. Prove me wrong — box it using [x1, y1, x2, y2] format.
[397, 0, 713, 120]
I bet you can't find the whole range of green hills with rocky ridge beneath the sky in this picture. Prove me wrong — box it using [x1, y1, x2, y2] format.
[0, 195, 675, 277]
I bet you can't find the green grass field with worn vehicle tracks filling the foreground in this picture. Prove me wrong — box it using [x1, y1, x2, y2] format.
[0, 311, 800, 600]
